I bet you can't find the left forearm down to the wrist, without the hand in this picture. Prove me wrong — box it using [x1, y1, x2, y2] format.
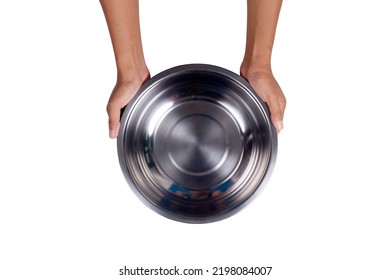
[100, 0, 146, 80]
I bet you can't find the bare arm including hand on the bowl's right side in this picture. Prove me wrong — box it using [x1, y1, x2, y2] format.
[241, 0, 286, 132]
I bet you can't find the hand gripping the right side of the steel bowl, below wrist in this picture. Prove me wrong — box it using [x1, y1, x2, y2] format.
[241, 67, 286, 133]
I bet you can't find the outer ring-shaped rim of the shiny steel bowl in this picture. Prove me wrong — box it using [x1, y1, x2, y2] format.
[117, 63, 278, 224]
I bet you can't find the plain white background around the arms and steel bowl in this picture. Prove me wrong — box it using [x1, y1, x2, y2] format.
[0, 0, 390, 280]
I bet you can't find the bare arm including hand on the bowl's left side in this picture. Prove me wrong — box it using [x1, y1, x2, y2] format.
[100, 0, 150, 138]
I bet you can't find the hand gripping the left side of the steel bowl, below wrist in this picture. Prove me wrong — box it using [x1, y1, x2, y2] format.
[107, 70, 150, 139]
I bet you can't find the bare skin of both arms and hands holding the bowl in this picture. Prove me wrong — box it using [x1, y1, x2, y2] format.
[100, 0, 286, 138]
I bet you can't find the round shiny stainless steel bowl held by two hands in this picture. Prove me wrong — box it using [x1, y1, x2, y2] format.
[118, 64, 277, 223]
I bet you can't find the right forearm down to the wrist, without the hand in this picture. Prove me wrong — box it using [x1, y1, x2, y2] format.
[243, 0, 282, 69]
